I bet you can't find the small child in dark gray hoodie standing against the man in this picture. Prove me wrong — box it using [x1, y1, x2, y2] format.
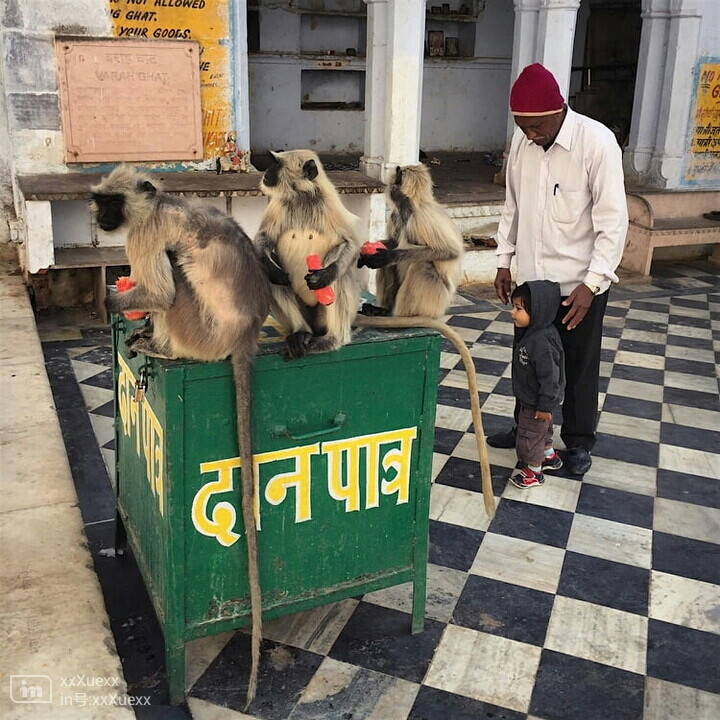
[510, 280, 565, 489]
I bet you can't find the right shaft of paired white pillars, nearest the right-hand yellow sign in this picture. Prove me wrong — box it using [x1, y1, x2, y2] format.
[646, 0, 702, 188]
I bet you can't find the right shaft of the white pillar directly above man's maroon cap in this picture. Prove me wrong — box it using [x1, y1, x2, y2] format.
[533, 0, 580, 100]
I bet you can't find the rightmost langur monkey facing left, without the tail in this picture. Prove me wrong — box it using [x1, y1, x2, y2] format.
[361, 165, 463, 317]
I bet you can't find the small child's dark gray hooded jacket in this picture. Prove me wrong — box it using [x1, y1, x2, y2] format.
[512, 280, 565, 412]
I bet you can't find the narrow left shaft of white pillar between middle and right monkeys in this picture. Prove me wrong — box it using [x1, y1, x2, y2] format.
[360, 0, 388, 180]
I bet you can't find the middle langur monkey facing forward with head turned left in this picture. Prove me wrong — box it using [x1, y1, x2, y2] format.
[255, 150, 360, 359]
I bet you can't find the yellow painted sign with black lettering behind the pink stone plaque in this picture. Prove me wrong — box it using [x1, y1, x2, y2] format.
[108, 0, 233, 158]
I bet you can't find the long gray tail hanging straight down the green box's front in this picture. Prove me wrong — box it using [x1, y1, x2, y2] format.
[232, 351, 262, 711]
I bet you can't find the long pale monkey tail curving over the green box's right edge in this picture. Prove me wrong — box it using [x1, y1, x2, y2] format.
[353, 315, 495, 518]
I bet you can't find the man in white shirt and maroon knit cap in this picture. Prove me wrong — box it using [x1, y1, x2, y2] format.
[488, 63, 628, 475]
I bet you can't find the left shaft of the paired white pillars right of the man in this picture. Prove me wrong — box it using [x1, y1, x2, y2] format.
[623, 0, 670, 184]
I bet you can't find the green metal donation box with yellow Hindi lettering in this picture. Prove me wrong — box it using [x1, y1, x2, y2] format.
[113, 316, 441, 702]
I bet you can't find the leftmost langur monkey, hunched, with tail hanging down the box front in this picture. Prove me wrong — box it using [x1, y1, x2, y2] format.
[91, 165, 270, 705]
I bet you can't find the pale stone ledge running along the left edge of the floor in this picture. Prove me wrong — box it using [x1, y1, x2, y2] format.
[0, 246, 134, 720]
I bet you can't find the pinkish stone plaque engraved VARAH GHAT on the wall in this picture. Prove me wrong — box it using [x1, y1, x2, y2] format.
[57, 40, 203, 163]
